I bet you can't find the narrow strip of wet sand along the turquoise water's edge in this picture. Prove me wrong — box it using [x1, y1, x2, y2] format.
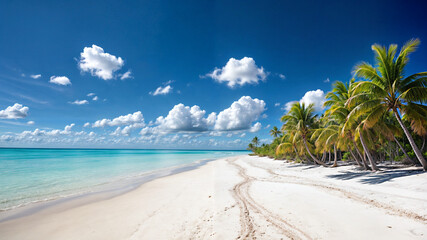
[0, 155, 231, 223]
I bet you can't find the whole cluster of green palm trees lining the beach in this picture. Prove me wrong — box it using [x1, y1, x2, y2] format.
[249, 39, 427, 171]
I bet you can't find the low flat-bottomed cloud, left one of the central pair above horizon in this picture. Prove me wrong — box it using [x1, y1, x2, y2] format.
[156, 103, 215, 132]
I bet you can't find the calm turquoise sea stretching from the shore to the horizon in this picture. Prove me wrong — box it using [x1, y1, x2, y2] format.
[0, 148, 246, 210]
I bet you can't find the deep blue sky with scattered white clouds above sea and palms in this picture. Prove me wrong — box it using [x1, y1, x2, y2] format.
[0, 0, 427, 149]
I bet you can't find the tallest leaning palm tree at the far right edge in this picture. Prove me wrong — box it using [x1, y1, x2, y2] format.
[348, 39, 427, 170]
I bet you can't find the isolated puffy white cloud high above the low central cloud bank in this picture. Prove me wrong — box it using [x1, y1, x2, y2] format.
[206, 57, 267, 88]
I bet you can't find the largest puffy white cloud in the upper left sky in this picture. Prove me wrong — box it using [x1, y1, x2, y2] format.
[79, 45, 124, 80]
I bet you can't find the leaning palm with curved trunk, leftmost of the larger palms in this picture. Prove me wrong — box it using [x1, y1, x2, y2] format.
[280, 102, 325, 166]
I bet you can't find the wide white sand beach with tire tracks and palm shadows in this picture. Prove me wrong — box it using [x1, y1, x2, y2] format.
[0, 156, 427, 240]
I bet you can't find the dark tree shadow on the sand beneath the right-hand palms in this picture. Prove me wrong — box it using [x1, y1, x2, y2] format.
[326, 170, 425, 184]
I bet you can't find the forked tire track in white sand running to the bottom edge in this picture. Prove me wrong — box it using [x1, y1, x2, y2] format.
[227, 159, 311, 239]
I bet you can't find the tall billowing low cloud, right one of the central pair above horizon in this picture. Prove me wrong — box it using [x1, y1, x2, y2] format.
[215, 96, 266, 131]
